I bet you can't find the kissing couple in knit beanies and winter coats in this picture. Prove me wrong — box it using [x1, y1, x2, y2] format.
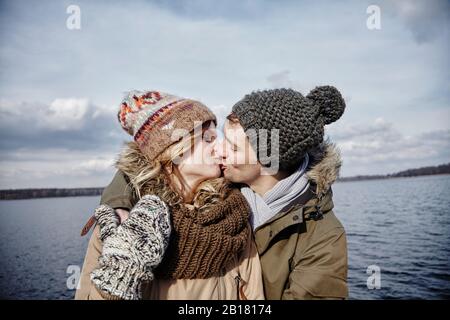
[75, 86, 348, 299]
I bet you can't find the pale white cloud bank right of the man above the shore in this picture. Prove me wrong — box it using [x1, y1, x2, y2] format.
[327, 118, 450, 176]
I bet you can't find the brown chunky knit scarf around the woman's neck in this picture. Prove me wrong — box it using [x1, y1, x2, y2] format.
[155, 189, 250, 279]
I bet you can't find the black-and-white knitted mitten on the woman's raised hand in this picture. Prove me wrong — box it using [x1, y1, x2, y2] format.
[91, 195, 171, 300]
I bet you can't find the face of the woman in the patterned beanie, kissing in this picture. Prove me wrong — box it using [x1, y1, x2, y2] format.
[178, 122, 221, 183]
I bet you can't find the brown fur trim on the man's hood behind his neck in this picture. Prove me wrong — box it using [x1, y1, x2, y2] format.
[306, 142, 342, 198]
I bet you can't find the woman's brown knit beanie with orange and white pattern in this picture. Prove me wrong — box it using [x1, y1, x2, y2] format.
[117, 91, 217, 160]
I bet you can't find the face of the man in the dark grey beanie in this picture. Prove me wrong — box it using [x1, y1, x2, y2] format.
[216, 120, 261, 184]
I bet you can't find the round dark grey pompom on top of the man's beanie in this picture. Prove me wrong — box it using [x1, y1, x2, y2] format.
[306, 86, 345, 124]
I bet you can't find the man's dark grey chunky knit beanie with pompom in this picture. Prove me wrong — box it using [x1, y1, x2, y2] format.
[232, 86, 345, 170]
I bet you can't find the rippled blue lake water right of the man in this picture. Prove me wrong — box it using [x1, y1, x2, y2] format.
[334, 176, 450, 299]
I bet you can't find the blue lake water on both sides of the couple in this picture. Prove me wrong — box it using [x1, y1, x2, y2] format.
[0, 176, 450, 299]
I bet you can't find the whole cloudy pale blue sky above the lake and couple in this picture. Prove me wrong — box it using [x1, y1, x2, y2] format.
[0, 0, 450, 189]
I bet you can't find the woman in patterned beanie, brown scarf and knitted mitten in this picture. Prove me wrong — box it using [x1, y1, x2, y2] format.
[75, 91, 264, 299]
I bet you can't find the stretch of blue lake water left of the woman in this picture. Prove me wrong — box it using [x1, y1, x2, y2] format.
[0, 197, 95, 299]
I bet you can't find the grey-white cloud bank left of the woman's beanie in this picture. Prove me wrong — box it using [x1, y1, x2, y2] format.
[0, 98, 127, 152]
